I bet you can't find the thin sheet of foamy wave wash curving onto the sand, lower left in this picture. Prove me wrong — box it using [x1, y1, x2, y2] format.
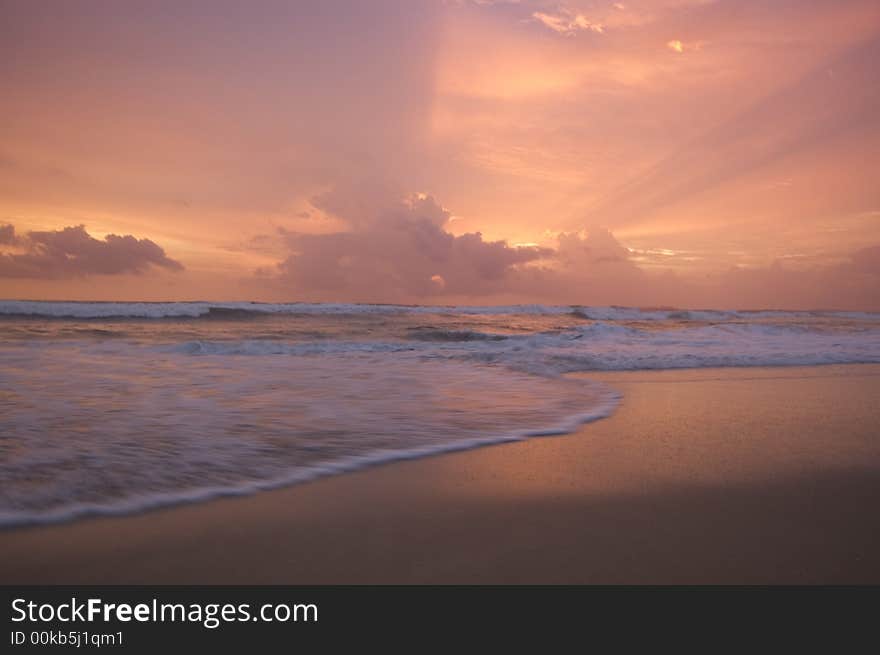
[0, 348, 620, 527]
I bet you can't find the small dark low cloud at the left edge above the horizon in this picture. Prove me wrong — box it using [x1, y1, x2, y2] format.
[0, 225, 183, 279]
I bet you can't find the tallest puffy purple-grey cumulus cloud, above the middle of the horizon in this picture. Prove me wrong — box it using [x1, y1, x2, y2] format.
[268, 191, 552, 301]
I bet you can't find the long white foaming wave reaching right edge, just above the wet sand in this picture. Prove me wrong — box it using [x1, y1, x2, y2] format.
[151, 322, 880, 377]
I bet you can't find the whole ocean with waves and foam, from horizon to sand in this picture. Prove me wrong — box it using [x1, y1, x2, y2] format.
[0, 301, 880, 526]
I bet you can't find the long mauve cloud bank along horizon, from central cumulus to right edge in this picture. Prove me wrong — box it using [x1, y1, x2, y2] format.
[259, 188, 880, 310]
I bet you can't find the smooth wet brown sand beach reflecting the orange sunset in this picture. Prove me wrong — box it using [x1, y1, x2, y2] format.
[0, 365, 880, 584]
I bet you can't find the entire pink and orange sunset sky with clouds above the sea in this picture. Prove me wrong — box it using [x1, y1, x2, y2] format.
[0, 0, 880, 311]
